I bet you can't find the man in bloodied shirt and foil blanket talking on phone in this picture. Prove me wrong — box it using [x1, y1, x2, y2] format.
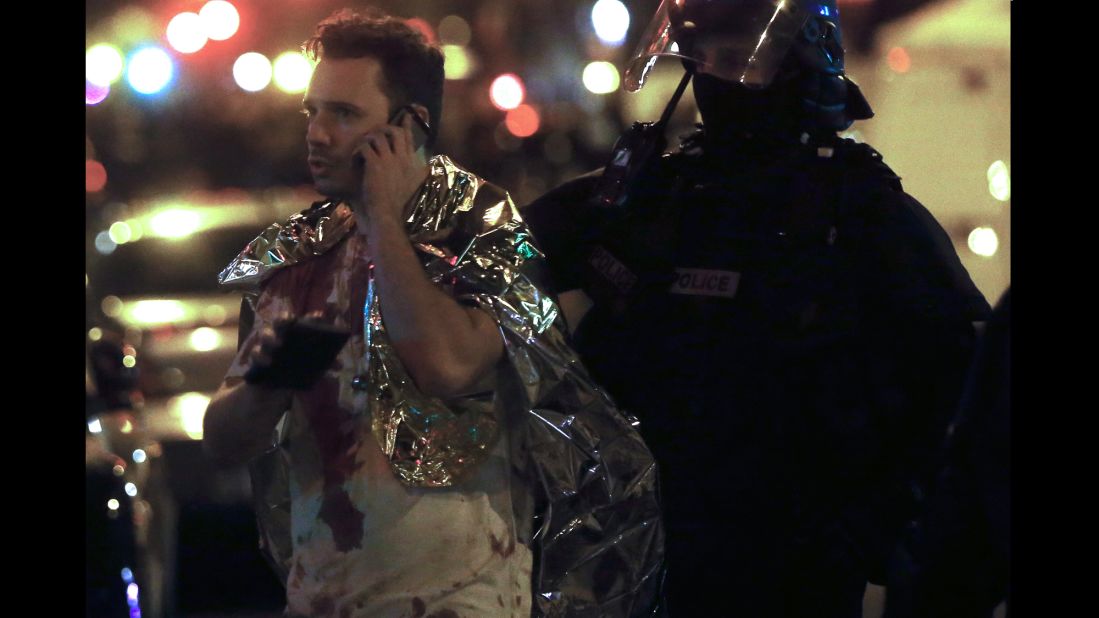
[204, 12, 662, 618]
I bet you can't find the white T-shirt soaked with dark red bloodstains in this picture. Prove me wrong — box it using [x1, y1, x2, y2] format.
[227, 228, 531, 618]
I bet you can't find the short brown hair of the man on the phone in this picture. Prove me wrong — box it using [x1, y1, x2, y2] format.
[302, 9, 444, 147]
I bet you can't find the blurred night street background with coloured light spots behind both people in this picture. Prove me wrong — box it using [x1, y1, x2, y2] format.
[85, 0, 1011, 618]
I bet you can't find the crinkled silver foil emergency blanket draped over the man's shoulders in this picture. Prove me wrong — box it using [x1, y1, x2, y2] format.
[220, 156, 664, 617]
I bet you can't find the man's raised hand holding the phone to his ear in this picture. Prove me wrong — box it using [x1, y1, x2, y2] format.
[356, 110, 428, 226]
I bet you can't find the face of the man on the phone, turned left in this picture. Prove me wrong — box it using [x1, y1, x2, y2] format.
[302, 57, 389, 199]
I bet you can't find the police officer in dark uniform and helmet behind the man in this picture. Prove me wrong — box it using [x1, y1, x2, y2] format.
[523, 0, 988, 617]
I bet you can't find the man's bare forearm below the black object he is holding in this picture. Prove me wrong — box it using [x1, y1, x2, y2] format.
[202, 378, 292, 465]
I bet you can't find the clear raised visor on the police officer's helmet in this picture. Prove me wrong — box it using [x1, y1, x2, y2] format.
[625, 0, 809, 92]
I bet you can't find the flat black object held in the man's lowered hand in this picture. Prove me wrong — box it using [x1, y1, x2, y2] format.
[244, 318, 351, 390]
